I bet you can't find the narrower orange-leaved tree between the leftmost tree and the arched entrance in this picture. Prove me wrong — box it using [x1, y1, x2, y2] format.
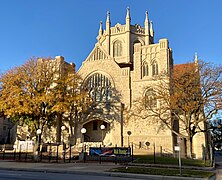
[52, 62, 91, 144]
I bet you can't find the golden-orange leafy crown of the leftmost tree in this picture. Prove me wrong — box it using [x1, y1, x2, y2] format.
[0, 59, 58, 141]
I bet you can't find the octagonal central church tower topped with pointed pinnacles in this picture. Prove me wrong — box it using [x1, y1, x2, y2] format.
[97, 7, 158, 66]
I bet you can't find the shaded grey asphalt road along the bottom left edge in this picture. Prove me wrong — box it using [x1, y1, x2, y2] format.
[0, 170, 142, 180]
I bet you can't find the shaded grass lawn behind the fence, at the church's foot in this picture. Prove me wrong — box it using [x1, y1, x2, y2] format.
[133, 155, 210, 167]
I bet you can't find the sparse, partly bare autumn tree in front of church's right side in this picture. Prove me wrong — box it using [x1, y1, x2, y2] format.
[131, 61, 222, 157]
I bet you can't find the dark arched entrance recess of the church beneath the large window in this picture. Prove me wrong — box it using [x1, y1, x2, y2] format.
[83, 120, 110, 142]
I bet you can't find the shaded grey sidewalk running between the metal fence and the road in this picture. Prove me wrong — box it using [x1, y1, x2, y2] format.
[0, 160, 217, 180]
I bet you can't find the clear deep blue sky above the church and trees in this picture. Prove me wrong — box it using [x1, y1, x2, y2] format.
[0, 0, 222, 72]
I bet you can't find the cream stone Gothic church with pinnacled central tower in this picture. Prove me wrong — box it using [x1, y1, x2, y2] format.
[77, 9, 206, 158]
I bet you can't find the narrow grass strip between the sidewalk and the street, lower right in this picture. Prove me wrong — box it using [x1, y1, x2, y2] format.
[111, 167, 215, 178]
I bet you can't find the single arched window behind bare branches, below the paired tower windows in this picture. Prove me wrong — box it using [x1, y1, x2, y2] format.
[144, 89, 157, 109]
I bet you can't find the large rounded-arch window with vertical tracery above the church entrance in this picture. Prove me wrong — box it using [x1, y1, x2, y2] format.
[84, 73, 112, 102]
